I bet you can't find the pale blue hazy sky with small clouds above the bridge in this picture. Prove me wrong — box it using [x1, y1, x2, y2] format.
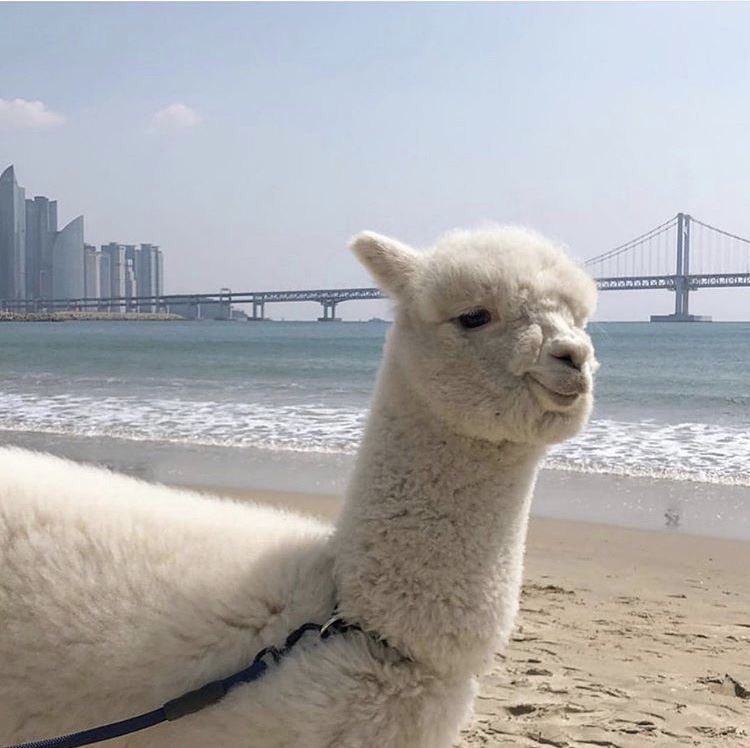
[0, 3, 750, 320]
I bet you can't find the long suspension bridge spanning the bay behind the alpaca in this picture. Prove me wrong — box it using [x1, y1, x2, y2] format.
[0, 213, 750, 322]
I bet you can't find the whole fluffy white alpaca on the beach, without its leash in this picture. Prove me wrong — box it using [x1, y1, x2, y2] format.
[0, 229, 596, 748]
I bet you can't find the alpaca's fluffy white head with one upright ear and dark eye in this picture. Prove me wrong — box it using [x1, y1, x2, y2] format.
[352, 222, 598, 445]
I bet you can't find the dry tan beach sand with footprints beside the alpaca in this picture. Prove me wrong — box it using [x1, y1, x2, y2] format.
[191, 490, 750, 748]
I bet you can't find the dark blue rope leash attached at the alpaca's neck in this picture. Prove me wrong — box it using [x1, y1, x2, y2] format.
[6, 615, 361, 748]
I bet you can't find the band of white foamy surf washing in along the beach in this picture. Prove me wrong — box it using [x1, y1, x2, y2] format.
[0, 393, 750, 485]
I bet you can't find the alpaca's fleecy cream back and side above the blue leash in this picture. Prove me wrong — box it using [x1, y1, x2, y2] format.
[0, 448, 333, 744]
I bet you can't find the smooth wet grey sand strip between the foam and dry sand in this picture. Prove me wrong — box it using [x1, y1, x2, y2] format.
[0, 431, 750, 540]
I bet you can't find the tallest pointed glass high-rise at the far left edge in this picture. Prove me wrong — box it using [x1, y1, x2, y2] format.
[0, 165, 26, 301]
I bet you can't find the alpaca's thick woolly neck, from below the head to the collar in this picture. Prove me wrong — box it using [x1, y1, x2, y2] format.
[334, 356, 542, 673]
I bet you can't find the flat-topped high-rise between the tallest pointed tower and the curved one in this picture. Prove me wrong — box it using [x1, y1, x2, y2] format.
[26, 195, 57, 299]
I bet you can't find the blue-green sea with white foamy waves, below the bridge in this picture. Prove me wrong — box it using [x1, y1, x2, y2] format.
[0, 322, 750, 486]
